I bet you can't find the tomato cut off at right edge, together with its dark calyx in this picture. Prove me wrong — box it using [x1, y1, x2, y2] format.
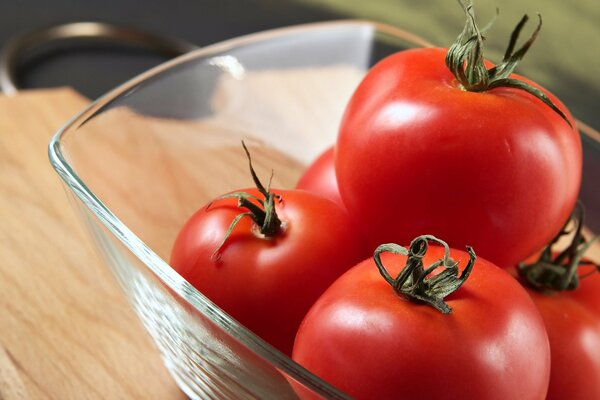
[518, 203, 600, 400]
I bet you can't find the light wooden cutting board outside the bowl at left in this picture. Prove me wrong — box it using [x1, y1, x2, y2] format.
[0, 89, 186, 400]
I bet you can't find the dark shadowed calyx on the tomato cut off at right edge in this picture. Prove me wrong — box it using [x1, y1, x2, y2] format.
[518, 202, 600, 292]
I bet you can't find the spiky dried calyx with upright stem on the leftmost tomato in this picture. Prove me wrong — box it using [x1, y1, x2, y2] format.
[207, 141, 282, 257]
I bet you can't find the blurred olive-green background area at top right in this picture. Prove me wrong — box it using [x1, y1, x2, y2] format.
[294, 0, 600, 129]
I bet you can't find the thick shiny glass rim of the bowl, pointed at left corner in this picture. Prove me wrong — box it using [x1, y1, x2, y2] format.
[48, 19, 432, 399]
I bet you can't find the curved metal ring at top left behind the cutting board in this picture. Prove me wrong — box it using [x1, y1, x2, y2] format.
[0, 22, 198, 95]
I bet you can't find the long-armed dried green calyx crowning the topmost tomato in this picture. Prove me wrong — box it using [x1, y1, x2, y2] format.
[446, 0, 572, 127]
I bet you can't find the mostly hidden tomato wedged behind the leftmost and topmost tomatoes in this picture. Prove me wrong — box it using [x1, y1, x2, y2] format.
[296, 147, 344, 207]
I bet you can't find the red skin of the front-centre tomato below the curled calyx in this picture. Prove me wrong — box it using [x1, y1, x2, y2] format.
[293, 246, 550, 400]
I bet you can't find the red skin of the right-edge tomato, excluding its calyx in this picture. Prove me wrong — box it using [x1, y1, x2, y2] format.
[528, 274, 600, 400]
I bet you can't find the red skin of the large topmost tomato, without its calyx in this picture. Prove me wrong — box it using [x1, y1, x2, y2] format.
[335, 49, 582, 267]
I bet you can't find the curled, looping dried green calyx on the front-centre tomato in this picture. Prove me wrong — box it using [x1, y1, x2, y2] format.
[373, 235, 477, 314]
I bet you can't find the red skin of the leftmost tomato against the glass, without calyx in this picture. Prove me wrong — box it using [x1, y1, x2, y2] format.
[171, 189, 365, 354]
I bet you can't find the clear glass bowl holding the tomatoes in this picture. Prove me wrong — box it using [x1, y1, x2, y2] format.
[49, 21, 600, 399]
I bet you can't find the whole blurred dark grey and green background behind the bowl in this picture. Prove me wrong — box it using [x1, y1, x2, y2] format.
[0, 0, 600, 129]
